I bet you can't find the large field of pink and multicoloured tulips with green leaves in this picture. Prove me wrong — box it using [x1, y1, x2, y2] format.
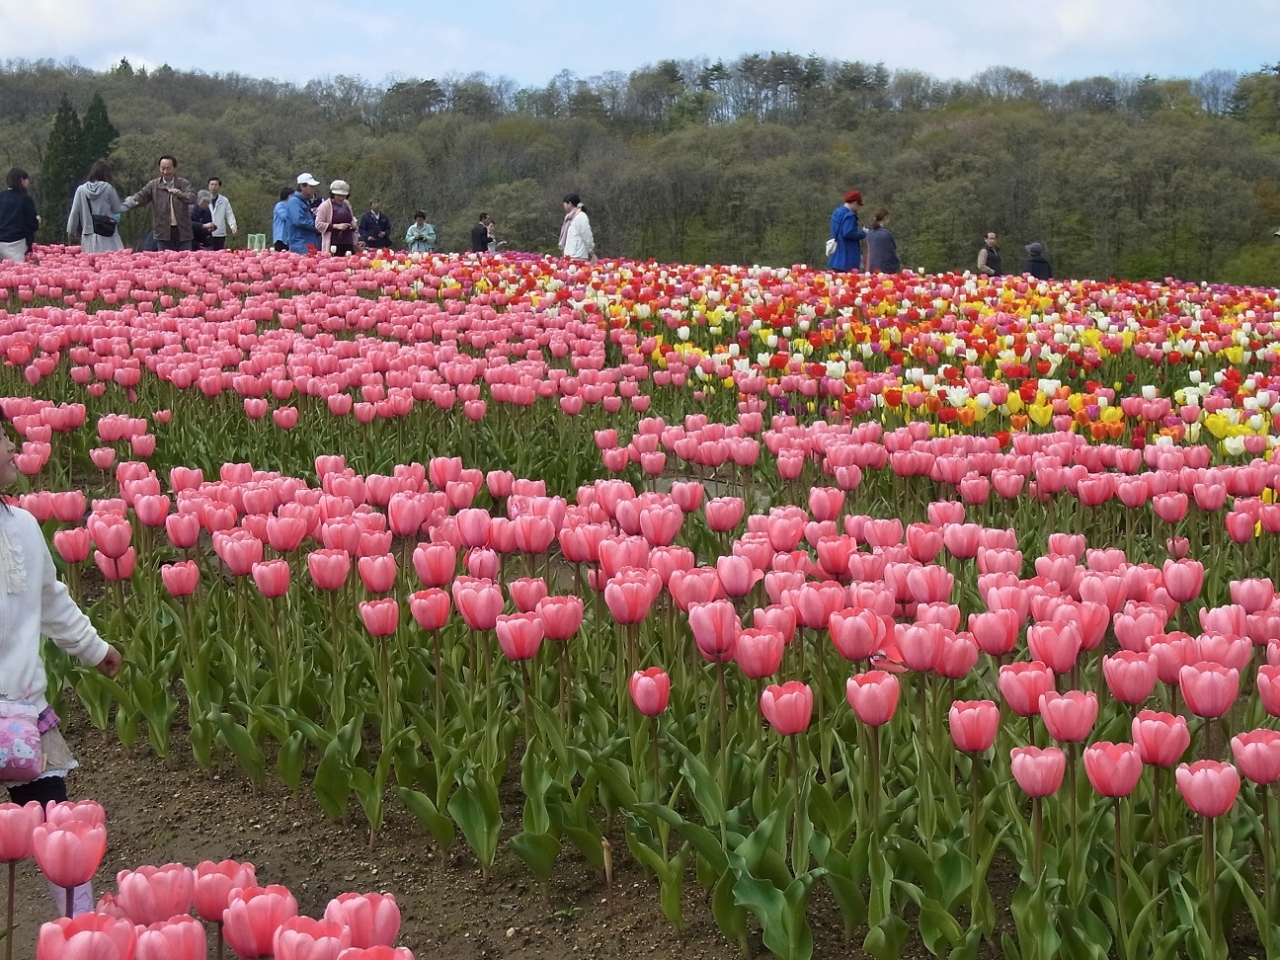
[0, 247, 1280, 960]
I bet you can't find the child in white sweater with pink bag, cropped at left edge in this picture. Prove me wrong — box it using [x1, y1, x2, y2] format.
[0, 415, 120, 914]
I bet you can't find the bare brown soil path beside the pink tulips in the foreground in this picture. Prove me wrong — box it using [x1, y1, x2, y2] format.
[7, 704, 1257, 960]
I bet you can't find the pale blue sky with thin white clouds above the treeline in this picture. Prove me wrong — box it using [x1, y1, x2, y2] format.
[0, 0, 1280, 86]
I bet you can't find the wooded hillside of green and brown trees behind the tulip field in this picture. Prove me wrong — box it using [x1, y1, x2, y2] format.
[0, 52, 1280, 285]
